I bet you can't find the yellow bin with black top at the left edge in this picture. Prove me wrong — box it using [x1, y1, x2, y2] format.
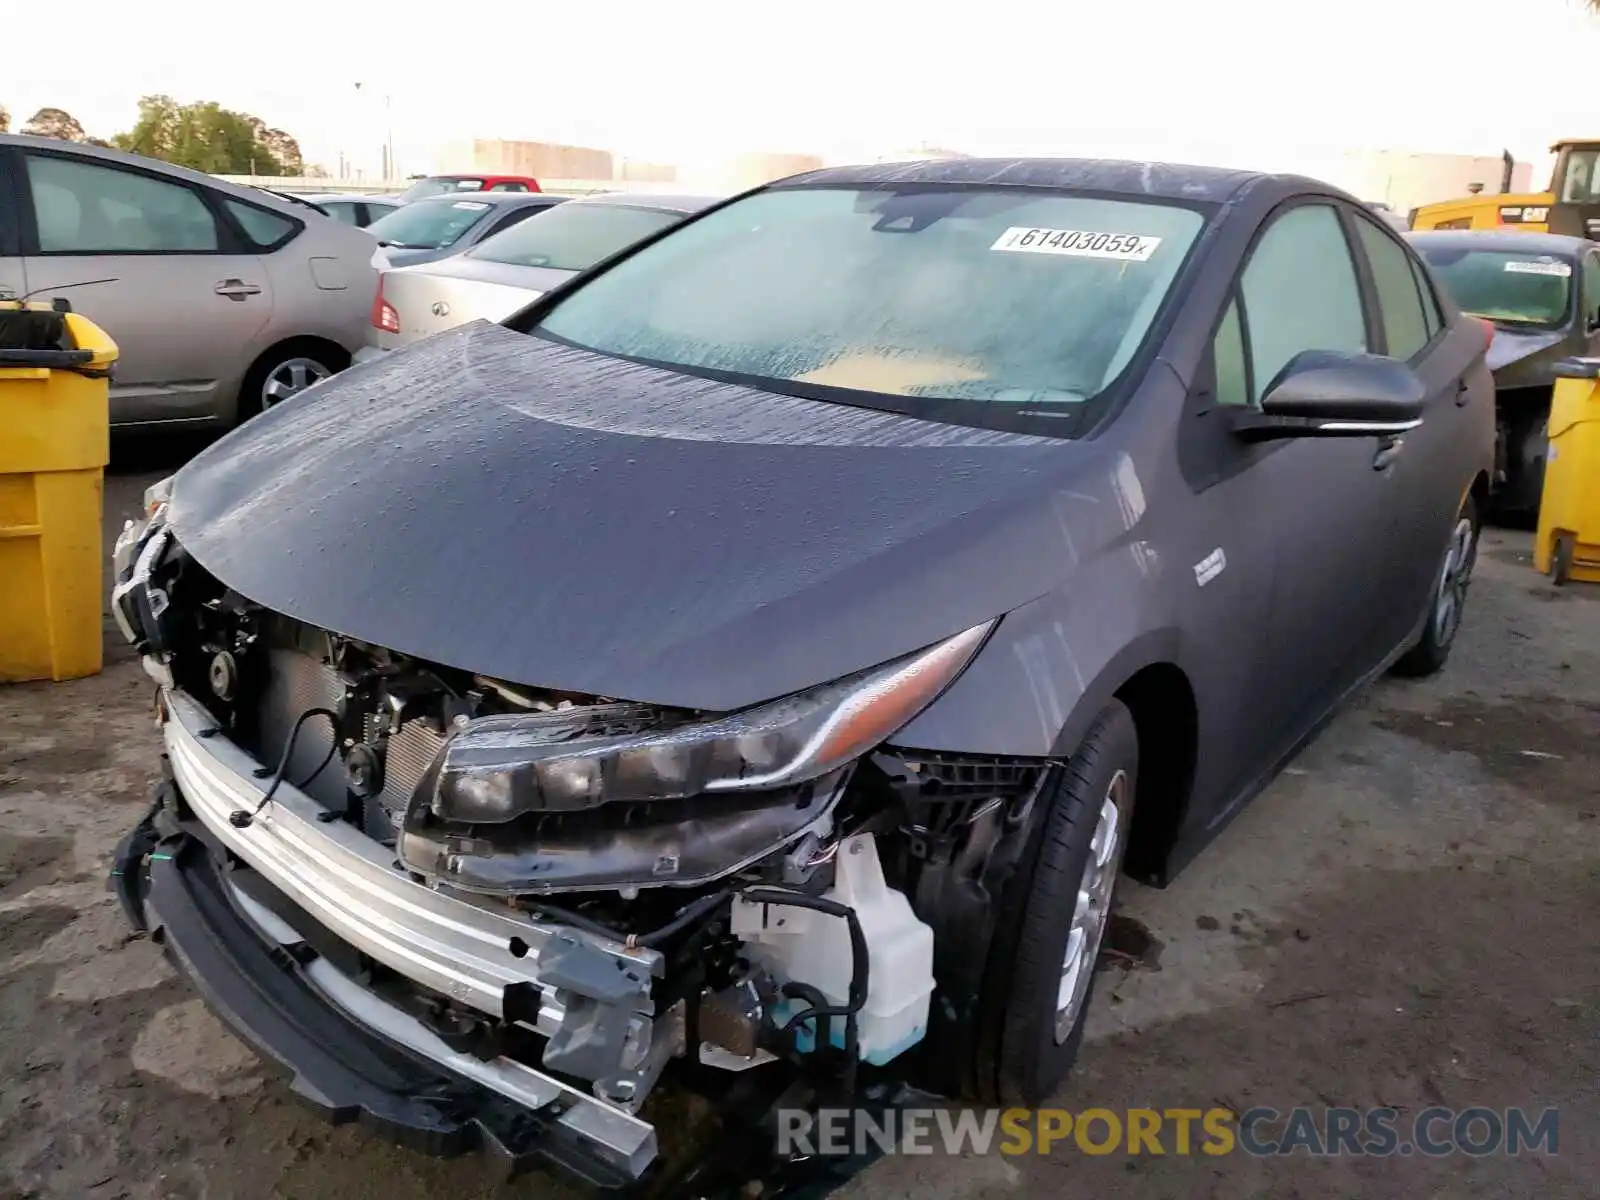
[0, 301, 117, 682]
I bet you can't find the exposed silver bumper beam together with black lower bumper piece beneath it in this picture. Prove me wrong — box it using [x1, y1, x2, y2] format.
[114, 693, 667, 1187]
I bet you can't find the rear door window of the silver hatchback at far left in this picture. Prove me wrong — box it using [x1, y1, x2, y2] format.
[24, 154, 221, 254]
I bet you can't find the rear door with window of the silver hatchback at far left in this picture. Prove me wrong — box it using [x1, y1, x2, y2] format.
[18, 149, 272, 422]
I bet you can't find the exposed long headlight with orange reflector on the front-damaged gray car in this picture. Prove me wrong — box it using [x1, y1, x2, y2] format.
[432, 621, 994, 822]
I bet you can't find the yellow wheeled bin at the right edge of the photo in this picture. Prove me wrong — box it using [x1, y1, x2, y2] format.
[1533, 358, 1600, 584]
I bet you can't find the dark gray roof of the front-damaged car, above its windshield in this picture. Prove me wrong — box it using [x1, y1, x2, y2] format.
[770, 158, 1260, 202]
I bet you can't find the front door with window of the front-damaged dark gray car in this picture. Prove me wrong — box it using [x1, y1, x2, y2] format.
[1179, 203, 1394, 826]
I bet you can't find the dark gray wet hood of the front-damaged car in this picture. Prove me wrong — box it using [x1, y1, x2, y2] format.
[170, 322, 1098, 710]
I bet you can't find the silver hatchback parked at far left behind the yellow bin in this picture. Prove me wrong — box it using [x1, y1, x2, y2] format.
[0, 134, 378, 427]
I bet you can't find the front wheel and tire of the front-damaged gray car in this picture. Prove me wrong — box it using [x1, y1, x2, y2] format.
[970, 701, 1139, 1106]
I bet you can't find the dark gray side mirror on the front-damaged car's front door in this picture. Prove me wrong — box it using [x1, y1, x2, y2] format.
[1229, 350, 1427, 442]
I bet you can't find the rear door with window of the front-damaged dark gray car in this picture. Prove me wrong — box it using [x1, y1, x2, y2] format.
[1350, 211, 1494, 648]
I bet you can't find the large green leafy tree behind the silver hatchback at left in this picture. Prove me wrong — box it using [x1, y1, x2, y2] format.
[112, 94, 289, 174]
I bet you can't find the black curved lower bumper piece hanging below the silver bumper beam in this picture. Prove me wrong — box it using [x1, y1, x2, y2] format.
[112, 800, 653, 1192]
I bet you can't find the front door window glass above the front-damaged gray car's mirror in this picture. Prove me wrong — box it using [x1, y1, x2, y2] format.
[1240, 205, 1368, 403]
